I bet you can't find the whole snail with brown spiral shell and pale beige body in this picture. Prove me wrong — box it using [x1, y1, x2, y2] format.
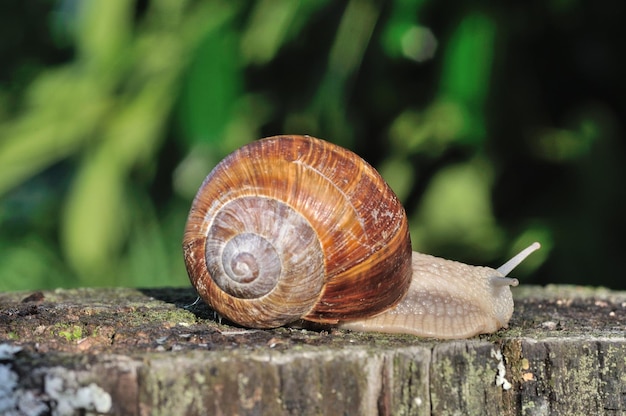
[183, 136, 539, 338]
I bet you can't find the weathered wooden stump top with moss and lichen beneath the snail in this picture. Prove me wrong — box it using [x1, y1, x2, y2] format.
[0, 286, 626, 415]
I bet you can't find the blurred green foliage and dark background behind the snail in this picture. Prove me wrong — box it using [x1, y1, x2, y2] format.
[0, 0, 626, 290]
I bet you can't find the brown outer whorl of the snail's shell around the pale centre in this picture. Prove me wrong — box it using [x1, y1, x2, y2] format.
[183, 136, 411, 327]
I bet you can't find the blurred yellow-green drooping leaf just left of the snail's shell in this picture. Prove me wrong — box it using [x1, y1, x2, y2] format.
[62, 76, 176, 284]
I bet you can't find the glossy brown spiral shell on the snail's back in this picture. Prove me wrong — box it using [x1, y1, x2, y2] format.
[183, 136, 411, 328]
